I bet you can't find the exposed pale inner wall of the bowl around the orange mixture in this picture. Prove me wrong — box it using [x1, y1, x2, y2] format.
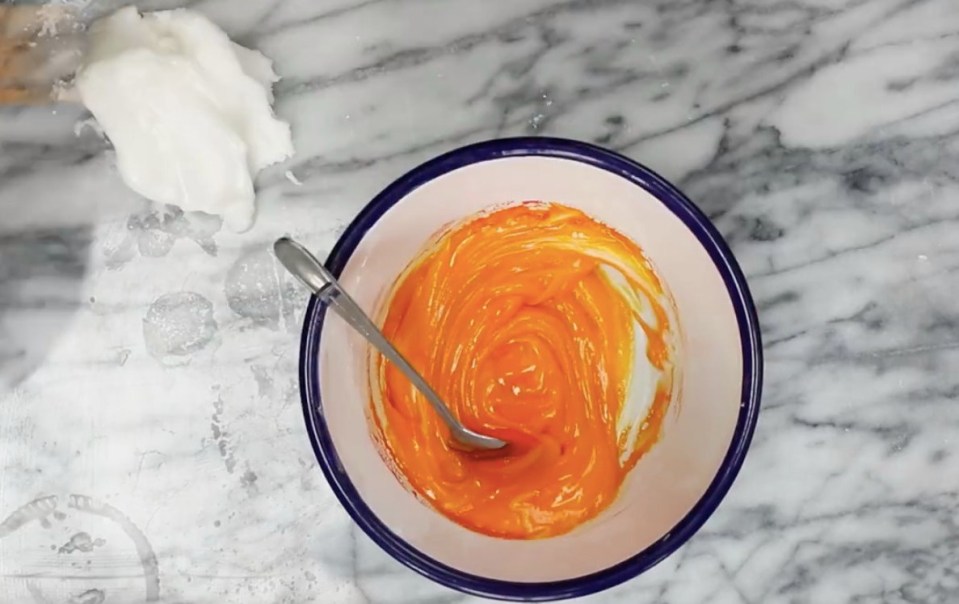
[319, 157, 743, 582]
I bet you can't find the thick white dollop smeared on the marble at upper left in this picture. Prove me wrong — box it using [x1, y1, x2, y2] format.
[76, 7, 293, 231]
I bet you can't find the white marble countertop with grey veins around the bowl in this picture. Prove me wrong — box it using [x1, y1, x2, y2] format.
[0, 0, 959, 604]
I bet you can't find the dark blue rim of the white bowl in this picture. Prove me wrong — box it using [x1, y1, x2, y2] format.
[299, 137, 763, 601]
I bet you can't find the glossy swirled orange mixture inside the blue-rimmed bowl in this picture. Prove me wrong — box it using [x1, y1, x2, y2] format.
[371, 202, 675, 539]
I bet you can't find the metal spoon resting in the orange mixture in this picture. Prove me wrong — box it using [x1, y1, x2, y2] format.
[273, 237, 506, 450]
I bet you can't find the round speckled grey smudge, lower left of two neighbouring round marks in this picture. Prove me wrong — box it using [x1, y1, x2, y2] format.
[143, 291, 217, 359]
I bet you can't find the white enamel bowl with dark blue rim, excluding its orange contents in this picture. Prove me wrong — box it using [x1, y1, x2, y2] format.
[300, 138, 762, 600]
